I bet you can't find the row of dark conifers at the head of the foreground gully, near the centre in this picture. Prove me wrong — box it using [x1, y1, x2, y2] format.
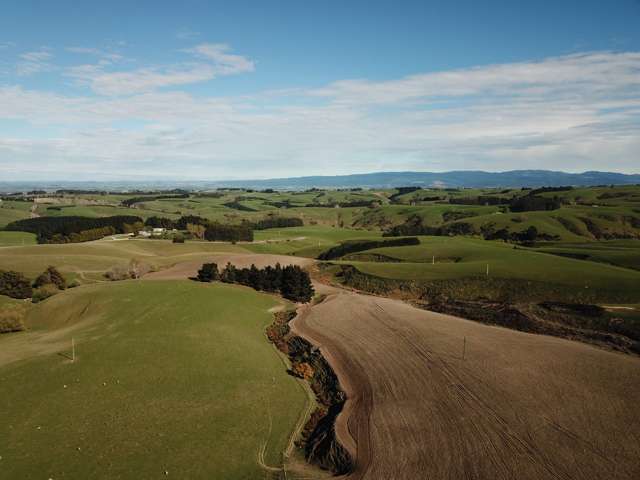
[197, 263, 314, 303]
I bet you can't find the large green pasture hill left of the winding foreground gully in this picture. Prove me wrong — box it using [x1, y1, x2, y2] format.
[0, 281, 305, 479]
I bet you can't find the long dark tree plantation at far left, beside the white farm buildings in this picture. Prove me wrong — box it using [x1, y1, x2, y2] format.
[5, 215, 143, 243]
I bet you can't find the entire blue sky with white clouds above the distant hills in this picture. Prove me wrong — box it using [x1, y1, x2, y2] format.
[0, 0, 640, 181]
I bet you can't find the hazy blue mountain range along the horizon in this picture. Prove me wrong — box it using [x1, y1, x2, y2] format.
[0, 170, 640, 192]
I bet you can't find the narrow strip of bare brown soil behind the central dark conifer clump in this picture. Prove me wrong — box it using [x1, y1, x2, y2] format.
[144, 253, 314, 280]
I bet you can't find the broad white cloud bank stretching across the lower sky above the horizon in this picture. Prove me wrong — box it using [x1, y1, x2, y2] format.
[0, 50, 640, 179]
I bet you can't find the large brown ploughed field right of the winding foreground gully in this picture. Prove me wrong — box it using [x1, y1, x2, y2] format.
[292, 292, 640, 480]
